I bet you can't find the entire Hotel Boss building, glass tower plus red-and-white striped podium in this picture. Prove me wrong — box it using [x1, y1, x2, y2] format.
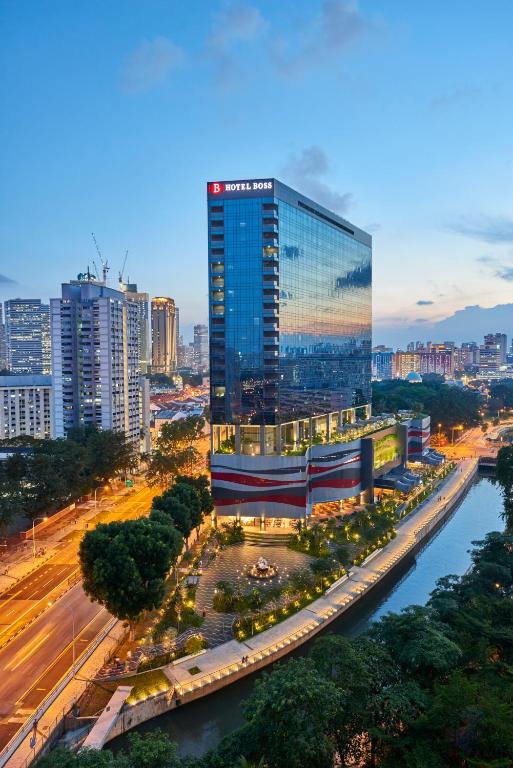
[208, 179, 429, 524]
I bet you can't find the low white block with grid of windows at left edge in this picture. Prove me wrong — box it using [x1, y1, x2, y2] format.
[0, 374, 53, 440]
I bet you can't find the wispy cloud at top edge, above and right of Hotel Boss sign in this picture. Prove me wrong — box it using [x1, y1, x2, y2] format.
[271, 0, 373, 76]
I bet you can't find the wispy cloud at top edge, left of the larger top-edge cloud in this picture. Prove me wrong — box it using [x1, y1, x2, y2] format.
[207, 0, 269, 85]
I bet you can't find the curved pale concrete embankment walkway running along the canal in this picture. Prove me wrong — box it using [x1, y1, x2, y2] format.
[99, 459, 477, 748]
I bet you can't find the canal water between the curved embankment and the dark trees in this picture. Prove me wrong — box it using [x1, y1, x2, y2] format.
[108, 478, 503, 756]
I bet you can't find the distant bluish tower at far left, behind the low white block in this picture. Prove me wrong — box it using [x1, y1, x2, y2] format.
[4, 299, 50, 375]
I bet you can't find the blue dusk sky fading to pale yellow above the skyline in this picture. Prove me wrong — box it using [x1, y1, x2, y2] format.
[0, 0, 513, 343]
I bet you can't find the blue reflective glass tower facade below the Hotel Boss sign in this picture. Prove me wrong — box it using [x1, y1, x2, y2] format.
[208, 180, 372, 444]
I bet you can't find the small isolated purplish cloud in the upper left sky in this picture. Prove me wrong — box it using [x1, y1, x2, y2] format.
[121, 36, 185, 93]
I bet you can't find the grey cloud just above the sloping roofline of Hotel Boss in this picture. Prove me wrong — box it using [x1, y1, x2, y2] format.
[282, 145, 353, 214]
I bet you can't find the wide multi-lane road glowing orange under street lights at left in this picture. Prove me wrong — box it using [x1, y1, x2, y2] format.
[0, 487, 159, 750]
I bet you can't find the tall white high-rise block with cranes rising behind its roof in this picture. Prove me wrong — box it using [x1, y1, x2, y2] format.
[50, 275, 141, 447]
